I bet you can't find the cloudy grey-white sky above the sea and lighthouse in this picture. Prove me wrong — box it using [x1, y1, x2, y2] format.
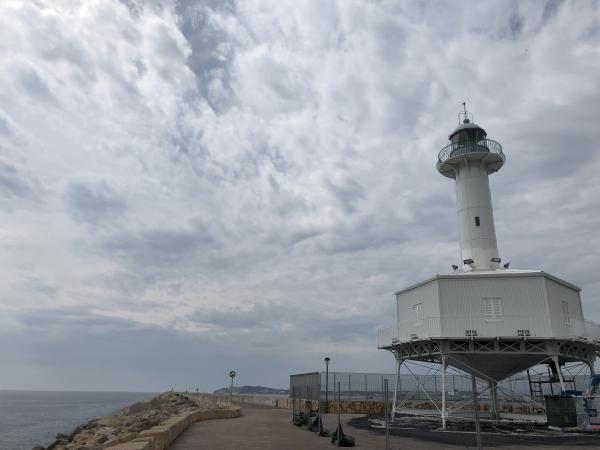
[0, 0, 600, 391]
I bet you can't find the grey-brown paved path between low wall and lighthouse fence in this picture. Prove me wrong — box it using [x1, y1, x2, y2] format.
[170, 406, 600, 450]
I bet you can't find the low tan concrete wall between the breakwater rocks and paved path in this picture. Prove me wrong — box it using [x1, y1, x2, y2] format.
[106, 406, 241, 450]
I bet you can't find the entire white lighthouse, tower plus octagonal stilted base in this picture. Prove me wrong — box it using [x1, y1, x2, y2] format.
[378, 104, 600, 426]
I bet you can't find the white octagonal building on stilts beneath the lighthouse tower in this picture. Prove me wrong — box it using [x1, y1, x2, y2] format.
[392, 269, 600, 381]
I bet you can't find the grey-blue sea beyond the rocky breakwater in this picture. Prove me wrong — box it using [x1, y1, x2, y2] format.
[0, 390, 156, 450]
